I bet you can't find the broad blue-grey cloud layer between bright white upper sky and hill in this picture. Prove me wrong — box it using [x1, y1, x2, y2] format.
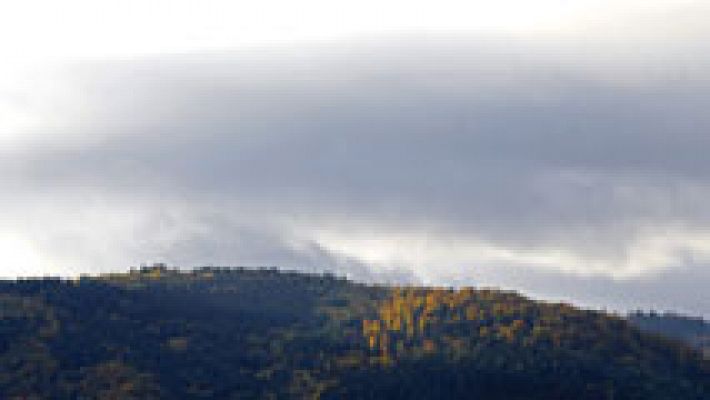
[0, 30, 710, 315]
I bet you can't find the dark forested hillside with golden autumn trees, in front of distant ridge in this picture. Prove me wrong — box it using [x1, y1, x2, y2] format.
[0, 267, 710, 400]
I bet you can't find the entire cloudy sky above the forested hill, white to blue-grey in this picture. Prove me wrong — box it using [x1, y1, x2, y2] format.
[0, 0, 710, 318]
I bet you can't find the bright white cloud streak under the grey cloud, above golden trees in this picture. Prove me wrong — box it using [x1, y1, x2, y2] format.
[306, 221, 710, 284]
